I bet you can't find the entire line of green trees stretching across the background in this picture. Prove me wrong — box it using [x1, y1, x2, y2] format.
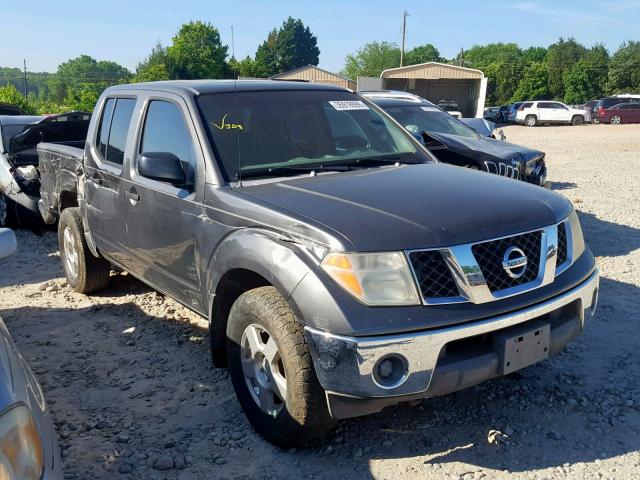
[0, 17, 640, 113]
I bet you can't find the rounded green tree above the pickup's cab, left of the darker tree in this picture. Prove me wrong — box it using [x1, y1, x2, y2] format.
[166, 21, 228, 79]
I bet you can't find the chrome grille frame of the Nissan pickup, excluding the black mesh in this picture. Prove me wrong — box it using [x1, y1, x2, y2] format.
[405, 219, 573, 305]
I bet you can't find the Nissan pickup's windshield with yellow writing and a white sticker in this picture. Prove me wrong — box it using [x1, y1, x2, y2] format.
[198, 90, 431, 180]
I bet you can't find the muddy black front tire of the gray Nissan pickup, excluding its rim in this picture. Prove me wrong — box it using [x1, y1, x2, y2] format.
[227, 287, 335, 448]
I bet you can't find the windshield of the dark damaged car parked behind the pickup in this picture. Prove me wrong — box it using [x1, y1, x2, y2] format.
[384, 105, 478, 138]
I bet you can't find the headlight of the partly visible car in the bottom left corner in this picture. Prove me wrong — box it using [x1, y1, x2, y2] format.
[0, 405, 44, 480]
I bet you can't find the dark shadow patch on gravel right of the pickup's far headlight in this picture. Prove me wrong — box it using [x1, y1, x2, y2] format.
[577, 210, 640, 257]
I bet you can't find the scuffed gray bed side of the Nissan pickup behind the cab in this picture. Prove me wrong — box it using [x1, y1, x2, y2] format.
[38, 142, 84, 224]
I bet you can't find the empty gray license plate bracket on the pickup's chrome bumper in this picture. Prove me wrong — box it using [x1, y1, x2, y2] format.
[493, 321, 551, 375]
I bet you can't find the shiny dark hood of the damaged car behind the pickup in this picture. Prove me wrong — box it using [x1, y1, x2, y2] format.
[428, 132, 544, 163]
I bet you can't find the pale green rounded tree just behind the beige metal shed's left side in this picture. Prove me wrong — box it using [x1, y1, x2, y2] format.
[342, 42, 400, 80]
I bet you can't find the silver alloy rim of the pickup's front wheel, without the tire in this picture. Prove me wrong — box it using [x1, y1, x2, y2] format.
[240, 324, 287, 417]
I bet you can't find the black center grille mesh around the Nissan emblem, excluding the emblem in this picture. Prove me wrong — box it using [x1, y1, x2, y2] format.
[471, 231, 542, 293]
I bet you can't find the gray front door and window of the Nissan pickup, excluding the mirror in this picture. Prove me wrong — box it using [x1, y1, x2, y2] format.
[124, 94, 204, 311]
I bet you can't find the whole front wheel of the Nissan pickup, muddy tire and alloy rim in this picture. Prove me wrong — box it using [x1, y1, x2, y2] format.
[227, 287, 334, 448]
